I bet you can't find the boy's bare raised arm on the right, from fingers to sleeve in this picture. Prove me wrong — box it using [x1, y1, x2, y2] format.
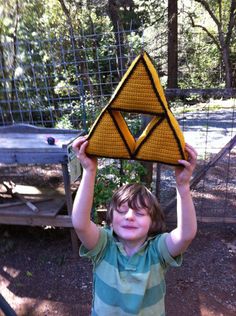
[166, 144, 197, 257]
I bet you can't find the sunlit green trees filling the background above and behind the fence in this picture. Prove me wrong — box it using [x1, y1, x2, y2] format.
[0, 0, 236, 128]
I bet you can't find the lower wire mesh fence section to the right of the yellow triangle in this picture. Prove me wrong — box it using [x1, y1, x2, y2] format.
[160, 98, 236, 223]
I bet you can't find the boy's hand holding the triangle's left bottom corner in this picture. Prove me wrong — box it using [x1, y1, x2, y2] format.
[72, 136, 97, 171]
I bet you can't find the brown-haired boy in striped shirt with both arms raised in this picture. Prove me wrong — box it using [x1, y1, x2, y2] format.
[72, 137, 197, 316]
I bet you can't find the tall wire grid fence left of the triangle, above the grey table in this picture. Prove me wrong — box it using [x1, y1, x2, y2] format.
[0, 31, 148, 128]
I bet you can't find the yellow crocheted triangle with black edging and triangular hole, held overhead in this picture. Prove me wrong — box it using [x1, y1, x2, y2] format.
[86, 52, 187, 165]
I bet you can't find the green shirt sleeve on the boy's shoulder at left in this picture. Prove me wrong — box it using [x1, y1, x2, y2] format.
[79, 228, 109, 264]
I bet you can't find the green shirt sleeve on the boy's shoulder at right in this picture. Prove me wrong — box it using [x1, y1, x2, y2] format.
[157, 233, 183, 267]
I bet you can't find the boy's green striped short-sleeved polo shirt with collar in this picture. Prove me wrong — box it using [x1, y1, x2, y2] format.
[80, 228, 182, 316]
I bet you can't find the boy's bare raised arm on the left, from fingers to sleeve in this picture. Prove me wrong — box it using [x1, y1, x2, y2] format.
[72, 137, 99, 250]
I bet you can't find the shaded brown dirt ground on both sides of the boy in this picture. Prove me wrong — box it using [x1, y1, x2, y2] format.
[0, 163, 236, 316]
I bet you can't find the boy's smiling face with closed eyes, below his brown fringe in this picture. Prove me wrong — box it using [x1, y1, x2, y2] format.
[112, 202, 151, 246]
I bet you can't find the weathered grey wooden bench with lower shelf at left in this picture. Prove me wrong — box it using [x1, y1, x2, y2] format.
[0, 124, 83, 255]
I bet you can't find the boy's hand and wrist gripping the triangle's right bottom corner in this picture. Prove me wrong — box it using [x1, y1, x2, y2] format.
[175, 144, 197, 188]
